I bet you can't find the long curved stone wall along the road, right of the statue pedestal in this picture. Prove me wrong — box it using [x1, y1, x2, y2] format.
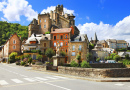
[58, 66, 130, 77]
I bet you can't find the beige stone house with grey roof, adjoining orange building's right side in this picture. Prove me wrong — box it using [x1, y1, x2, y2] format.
[68, 34, 89, 63]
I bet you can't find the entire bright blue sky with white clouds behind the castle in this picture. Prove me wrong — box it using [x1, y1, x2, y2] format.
[0, 0, 130, 42]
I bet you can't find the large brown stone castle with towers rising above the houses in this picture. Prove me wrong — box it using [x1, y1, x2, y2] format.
[28, 5, 79, 37]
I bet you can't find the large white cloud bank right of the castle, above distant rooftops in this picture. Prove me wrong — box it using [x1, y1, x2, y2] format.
[77, 16, 130, 42]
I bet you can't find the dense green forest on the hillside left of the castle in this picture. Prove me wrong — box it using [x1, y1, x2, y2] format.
[0, 21, 28, 46]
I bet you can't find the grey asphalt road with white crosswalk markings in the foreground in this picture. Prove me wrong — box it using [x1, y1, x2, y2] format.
[0, 63, 130, 90]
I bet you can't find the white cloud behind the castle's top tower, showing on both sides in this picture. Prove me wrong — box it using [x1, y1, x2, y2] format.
[41, 6, 75, 14]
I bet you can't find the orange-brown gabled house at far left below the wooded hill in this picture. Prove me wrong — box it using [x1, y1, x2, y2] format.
[0, 33, 21, 60]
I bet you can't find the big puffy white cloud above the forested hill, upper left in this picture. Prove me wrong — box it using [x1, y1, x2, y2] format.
[0, 0, 38, 21]
